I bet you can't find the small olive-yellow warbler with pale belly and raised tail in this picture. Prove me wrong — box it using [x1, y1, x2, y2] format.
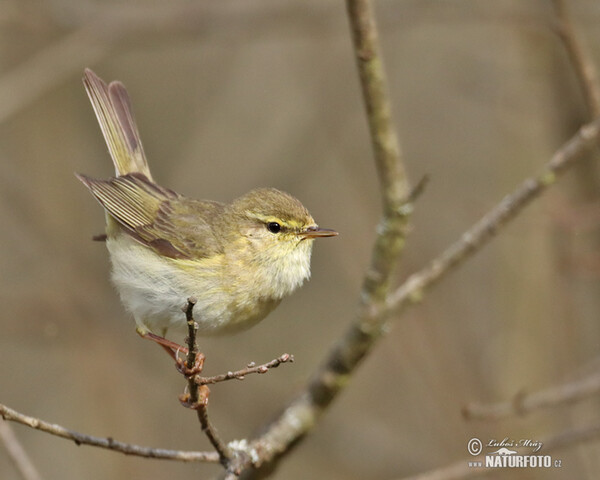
[77, 69, 337, 343]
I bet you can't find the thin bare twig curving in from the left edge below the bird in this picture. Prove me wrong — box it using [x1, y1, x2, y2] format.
[0, 404, 219, 463]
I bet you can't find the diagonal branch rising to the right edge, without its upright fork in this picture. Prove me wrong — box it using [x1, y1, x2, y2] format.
[237, 120, 600, 476]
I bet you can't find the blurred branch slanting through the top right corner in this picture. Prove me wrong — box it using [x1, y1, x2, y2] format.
[552, 0, 600, 118]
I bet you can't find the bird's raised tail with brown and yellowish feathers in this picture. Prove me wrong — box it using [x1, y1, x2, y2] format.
[83, 68, 152, 181]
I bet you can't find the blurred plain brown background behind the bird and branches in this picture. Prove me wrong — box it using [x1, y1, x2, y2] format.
[0, 0, 600, 480]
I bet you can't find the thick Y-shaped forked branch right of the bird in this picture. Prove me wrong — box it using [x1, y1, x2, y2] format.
[229, 0, 600, 476]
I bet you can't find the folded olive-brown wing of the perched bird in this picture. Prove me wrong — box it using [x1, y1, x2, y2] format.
[77, 173, 224, 259]
